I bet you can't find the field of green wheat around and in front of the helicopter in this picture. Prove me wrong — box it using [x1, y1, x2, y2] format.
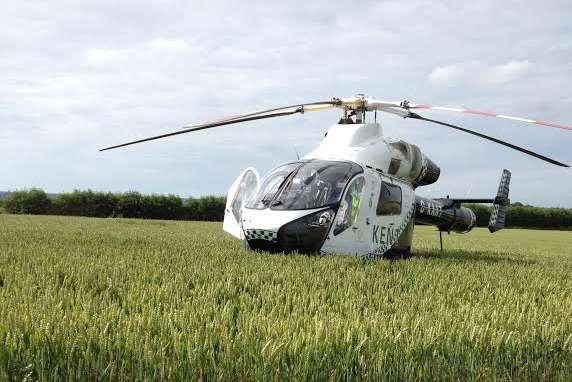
[0, 215, 572, 381]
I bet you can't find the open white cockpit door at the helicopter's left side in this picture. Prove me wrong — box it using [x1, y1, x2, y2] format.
[222, 167, 260, 239]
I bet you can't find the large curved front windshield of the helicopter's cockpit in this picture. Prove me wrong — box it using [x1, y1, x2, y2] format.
[246, 160, 363, 210]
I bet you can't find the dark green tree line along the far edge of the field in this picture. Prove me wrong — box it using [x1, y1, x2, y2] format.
[0, 188, 572, 229]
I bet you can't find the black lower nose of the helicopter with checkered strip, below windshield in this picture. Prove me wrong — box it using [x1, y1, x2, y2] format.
[245, 208, 335, 254]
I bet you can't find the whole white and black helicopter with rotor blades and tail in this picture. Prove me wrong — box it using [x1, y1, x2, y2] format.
[100, 94, 572, 259]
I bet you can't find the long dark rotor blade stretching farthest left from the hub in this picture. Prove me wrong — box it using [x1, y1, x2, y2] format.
[99, 99, 339, 151]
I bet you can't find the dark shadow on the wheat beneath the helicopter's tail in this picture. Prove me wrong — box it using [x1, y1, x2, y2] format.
[413, 250, 536, 265]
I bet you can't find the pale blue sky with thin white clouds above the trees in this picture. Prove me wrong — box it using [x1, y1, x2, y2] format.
[0, 0, 572, 208]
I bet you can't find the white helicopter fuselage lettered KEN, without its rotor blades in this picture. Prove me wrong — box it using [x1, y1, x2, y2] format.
[224, 123, 474, 257]
